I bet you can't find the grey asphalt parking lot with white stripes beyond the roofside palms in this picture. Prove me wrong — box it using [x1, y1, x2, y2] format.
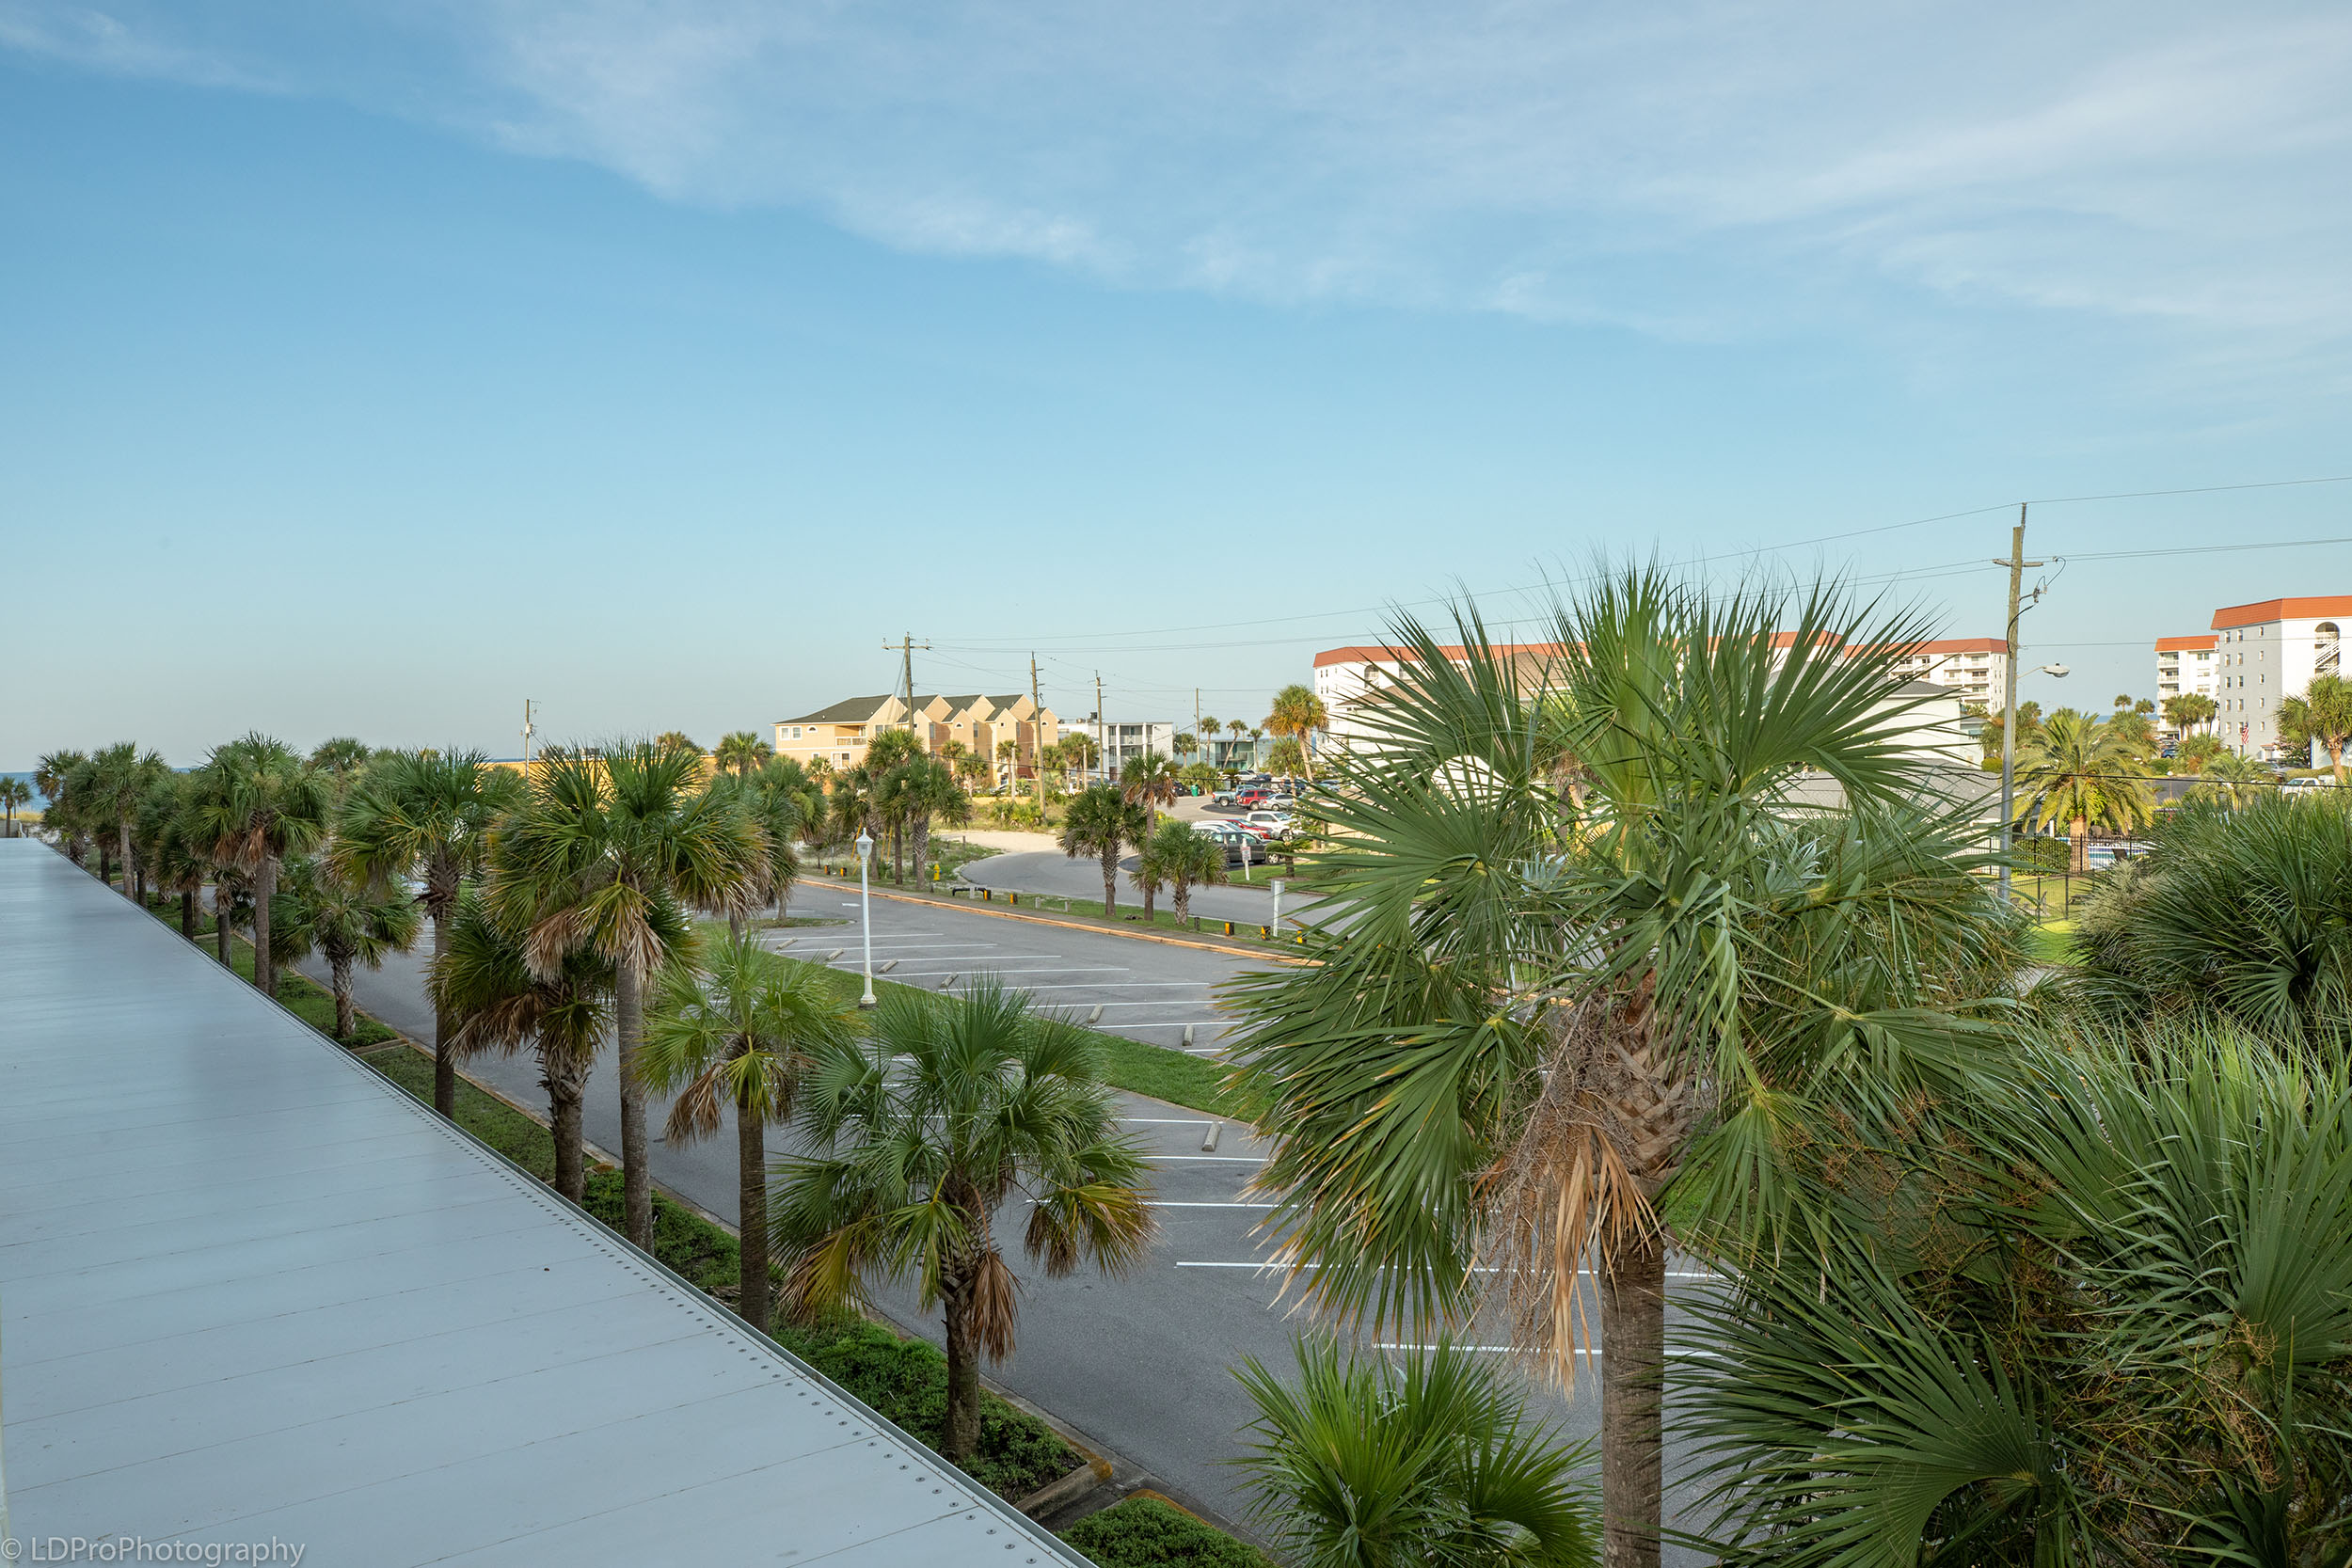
[304, 881, 1712, 1561]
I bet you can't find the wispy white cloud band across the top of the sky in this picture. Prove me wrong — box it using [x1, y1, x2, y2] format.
[0, 0, 2352, 345]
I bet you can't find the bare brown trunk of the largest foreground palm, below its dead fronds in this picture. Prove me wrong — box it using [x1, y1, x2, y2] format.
[1599, 1239, 1665, 1568]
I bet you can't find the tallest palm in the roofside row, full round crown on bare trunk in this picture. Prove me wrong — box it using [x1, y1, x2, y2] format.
[489, 740, 770, 1248]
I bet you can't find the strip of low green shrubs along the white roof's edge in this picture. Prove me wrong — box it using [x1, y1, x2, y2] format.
[360, 1041, 1082, 1502]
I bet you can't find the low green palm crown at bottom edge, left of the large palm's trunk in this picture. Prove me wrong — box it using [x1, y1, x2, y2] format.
[1235, 1338, 1599, 1568]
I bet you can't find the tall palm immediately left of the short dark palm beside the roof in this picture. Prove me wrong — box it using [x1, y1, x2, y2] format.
[332, 750, 527, 1117]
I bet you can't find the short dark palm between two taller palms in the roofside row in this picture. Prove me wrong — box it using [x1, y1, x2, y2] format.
[428, 889, 614, 1204]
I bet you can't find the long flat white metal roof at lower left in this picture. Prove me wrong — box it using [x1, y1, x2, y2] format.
[0, 839, 1085, 1568]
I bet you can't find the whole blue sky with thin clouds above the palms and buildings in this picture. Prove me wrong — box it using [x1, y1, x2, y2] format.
[0, 0, 2352, 767]
